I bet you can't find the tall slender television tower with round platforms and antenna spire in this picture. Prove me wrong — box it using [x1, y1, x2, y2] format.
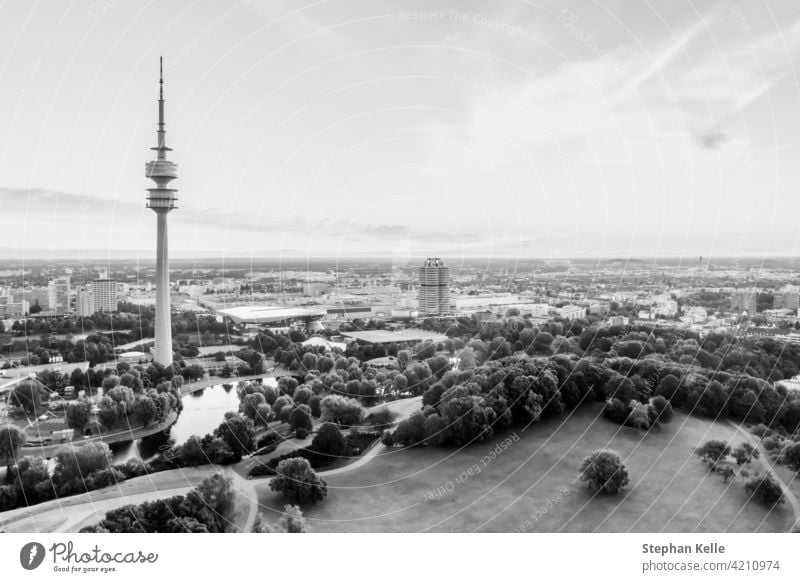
[145, 57, 178, 366]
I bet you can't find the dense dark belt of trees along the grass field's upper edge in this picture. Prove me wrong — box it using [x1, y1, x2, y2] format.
[394, 319, 800, 452]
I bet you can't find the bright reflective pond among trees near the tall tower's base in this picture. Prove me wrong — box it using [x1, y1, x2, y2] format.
[111, 378, 277, 463]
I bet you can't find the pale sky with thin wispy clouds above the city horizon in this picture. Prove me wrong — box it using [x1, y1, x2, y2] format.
[0, 0, 800, 262]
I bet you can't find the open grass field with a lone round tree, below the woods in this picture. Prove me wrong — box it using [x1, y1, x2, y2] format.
[258, 405, 793, 532]
